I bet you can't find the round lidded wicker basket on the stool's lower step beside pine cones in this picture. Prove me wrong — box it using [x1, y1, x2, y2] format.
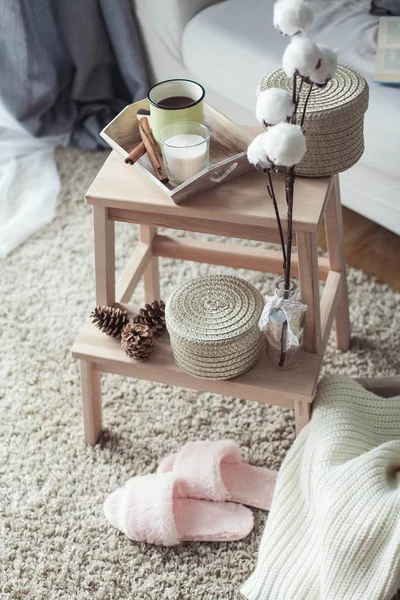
[165, 275, 264, 379]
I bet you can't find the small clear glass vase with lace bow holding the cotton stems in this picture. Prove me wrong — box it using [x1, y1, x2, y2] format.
[265, 278, 307, 370]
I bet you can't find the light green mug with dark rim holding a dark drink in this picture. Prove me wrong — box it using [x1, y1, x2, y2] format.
[147, 79, 205, 143]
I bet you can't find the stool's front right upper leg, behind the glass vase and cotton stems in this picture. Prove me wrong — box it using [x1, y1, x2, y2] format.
[296, 231, 321, 354]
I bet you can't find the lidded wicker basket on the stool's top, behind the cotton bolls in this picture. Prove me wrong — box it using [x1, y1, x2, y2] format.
[257, 65, 369, 177]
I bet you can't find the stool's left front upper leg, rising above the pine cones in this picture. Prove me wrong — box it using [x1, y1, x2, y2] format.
[93, 206, 115, 306]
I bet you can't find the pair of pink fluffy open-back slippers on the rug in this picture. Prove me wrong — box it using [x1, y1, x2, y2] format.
[104, 440, 277, 546]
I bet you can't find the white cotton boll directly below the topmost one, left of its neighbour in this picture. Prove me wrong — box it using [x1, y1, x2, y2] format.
[282, 36, 322, 79]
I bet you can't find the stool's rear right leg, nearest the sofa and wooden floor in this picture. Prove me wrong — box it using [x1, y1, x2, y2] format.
[325, 175, 350, 351]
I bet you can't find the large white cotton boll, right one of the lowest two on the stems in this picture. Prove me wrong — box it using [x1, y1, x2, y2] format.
[262, 123, 307, 167]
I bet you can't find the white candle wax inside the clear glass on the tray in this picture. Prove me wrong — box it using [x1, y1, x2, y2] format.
[164, 133, 208, 182]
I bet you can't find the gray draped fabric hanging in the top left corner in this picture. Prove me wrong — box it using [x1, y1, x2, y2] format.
[0, 0, 148, 150]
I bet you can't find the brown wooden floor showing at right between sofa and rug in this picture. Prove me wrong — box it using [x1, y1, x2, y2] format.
[318, 208, 400, 291]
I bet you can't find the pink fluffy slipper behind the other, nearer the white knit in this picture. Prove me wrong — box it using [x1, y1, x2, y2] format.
[157, 440, 278, 510]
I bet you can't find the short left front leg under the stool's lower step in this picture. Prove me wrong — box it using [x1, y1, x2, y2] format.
[79, 360, 102, 446]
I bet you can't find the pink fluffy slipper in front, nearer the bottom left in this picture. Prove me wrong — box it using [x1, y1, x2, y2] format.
[104, 473, 253, 546]
